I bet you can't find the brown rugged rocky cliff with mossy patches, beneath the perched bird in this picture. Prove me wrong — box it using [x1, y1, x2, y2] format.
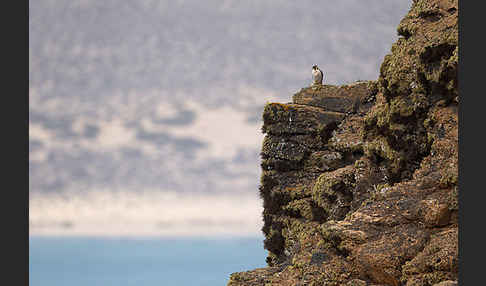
[228, 0, 459, 286]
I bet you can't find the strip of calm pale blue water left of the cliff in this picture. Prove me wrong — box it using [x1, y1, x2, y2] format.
[29, 237, 267, 286]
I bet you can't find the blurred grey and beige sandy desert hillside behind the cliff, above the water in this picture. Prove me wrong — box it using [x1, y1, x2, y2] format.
[29, 0, 411, 237]
